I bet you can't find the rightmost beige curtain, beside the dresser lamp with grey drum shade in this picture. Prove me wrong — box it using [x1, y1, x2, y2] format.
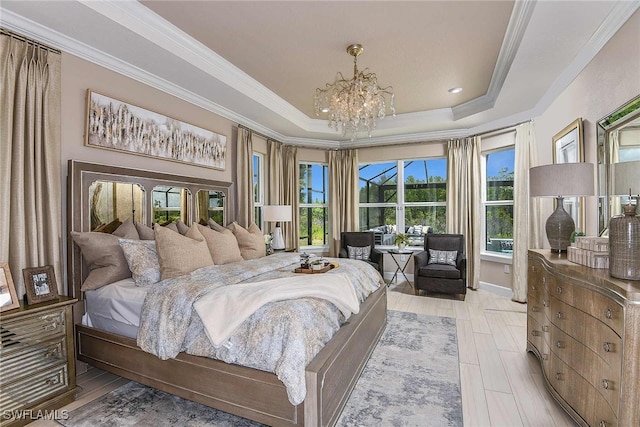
[512, 122, 542, 302]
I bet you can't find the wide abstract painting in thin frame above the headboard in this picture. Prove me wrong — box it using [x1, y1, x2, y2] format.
[85, 89, 227, 170]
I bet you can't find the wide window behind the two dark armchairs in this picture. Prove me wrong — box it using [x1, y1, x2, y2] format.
[359, 158, 447, 246]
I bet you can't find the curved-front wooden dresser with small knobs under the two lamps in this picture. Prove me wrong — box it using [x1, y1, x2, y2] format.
[527, 249, 640, 427]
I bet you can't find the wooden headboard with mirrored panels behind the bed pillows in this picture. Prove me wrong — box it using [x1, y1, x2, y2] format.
[67, 160, 233, 299]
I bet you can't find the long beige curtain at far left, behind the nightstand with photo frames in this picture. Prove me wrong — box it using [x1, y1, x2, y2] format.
[0, 34, 66, 297]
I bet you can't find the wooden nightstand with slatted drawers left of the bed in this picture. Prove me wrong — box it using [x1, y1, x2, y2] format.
[0, 296, 77, 427]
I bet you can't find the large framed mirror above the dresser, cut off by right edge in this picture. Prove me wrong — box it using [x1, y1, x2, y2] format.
[596, 95, 640, 235]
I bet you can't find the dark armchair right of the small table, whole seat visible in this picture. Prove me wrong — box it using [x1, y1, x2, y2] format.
[413, 234, 467, 300]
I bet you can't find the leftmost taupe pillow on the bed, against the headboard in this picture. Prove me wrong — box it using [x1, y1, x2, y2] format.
[71, 231, 131, 291]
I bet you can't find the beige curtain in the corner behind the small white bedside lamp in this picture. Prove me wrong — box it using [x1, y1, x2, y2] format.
[265, 139, 300, 250]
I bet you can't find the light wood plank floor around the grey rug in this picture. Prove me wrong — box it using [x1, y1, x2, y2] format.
[31, 282, 575, 427]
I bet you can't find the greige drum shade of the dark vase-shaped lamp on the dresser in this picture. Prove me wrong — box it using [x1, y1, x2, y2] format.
[529, 163, 595, 197]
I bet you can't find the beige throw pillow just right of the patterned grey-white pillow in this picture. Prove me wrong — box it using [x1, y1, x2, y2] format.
[153, 224, 213, 280]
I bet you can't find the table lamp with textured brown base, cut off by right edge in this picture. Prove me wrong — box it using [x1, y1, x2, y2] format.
[609, 161, 640, 280]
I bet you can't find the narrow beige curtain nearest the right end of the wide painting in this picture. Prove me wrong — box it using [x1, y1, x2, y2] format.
[236, 127, 255, 227]
